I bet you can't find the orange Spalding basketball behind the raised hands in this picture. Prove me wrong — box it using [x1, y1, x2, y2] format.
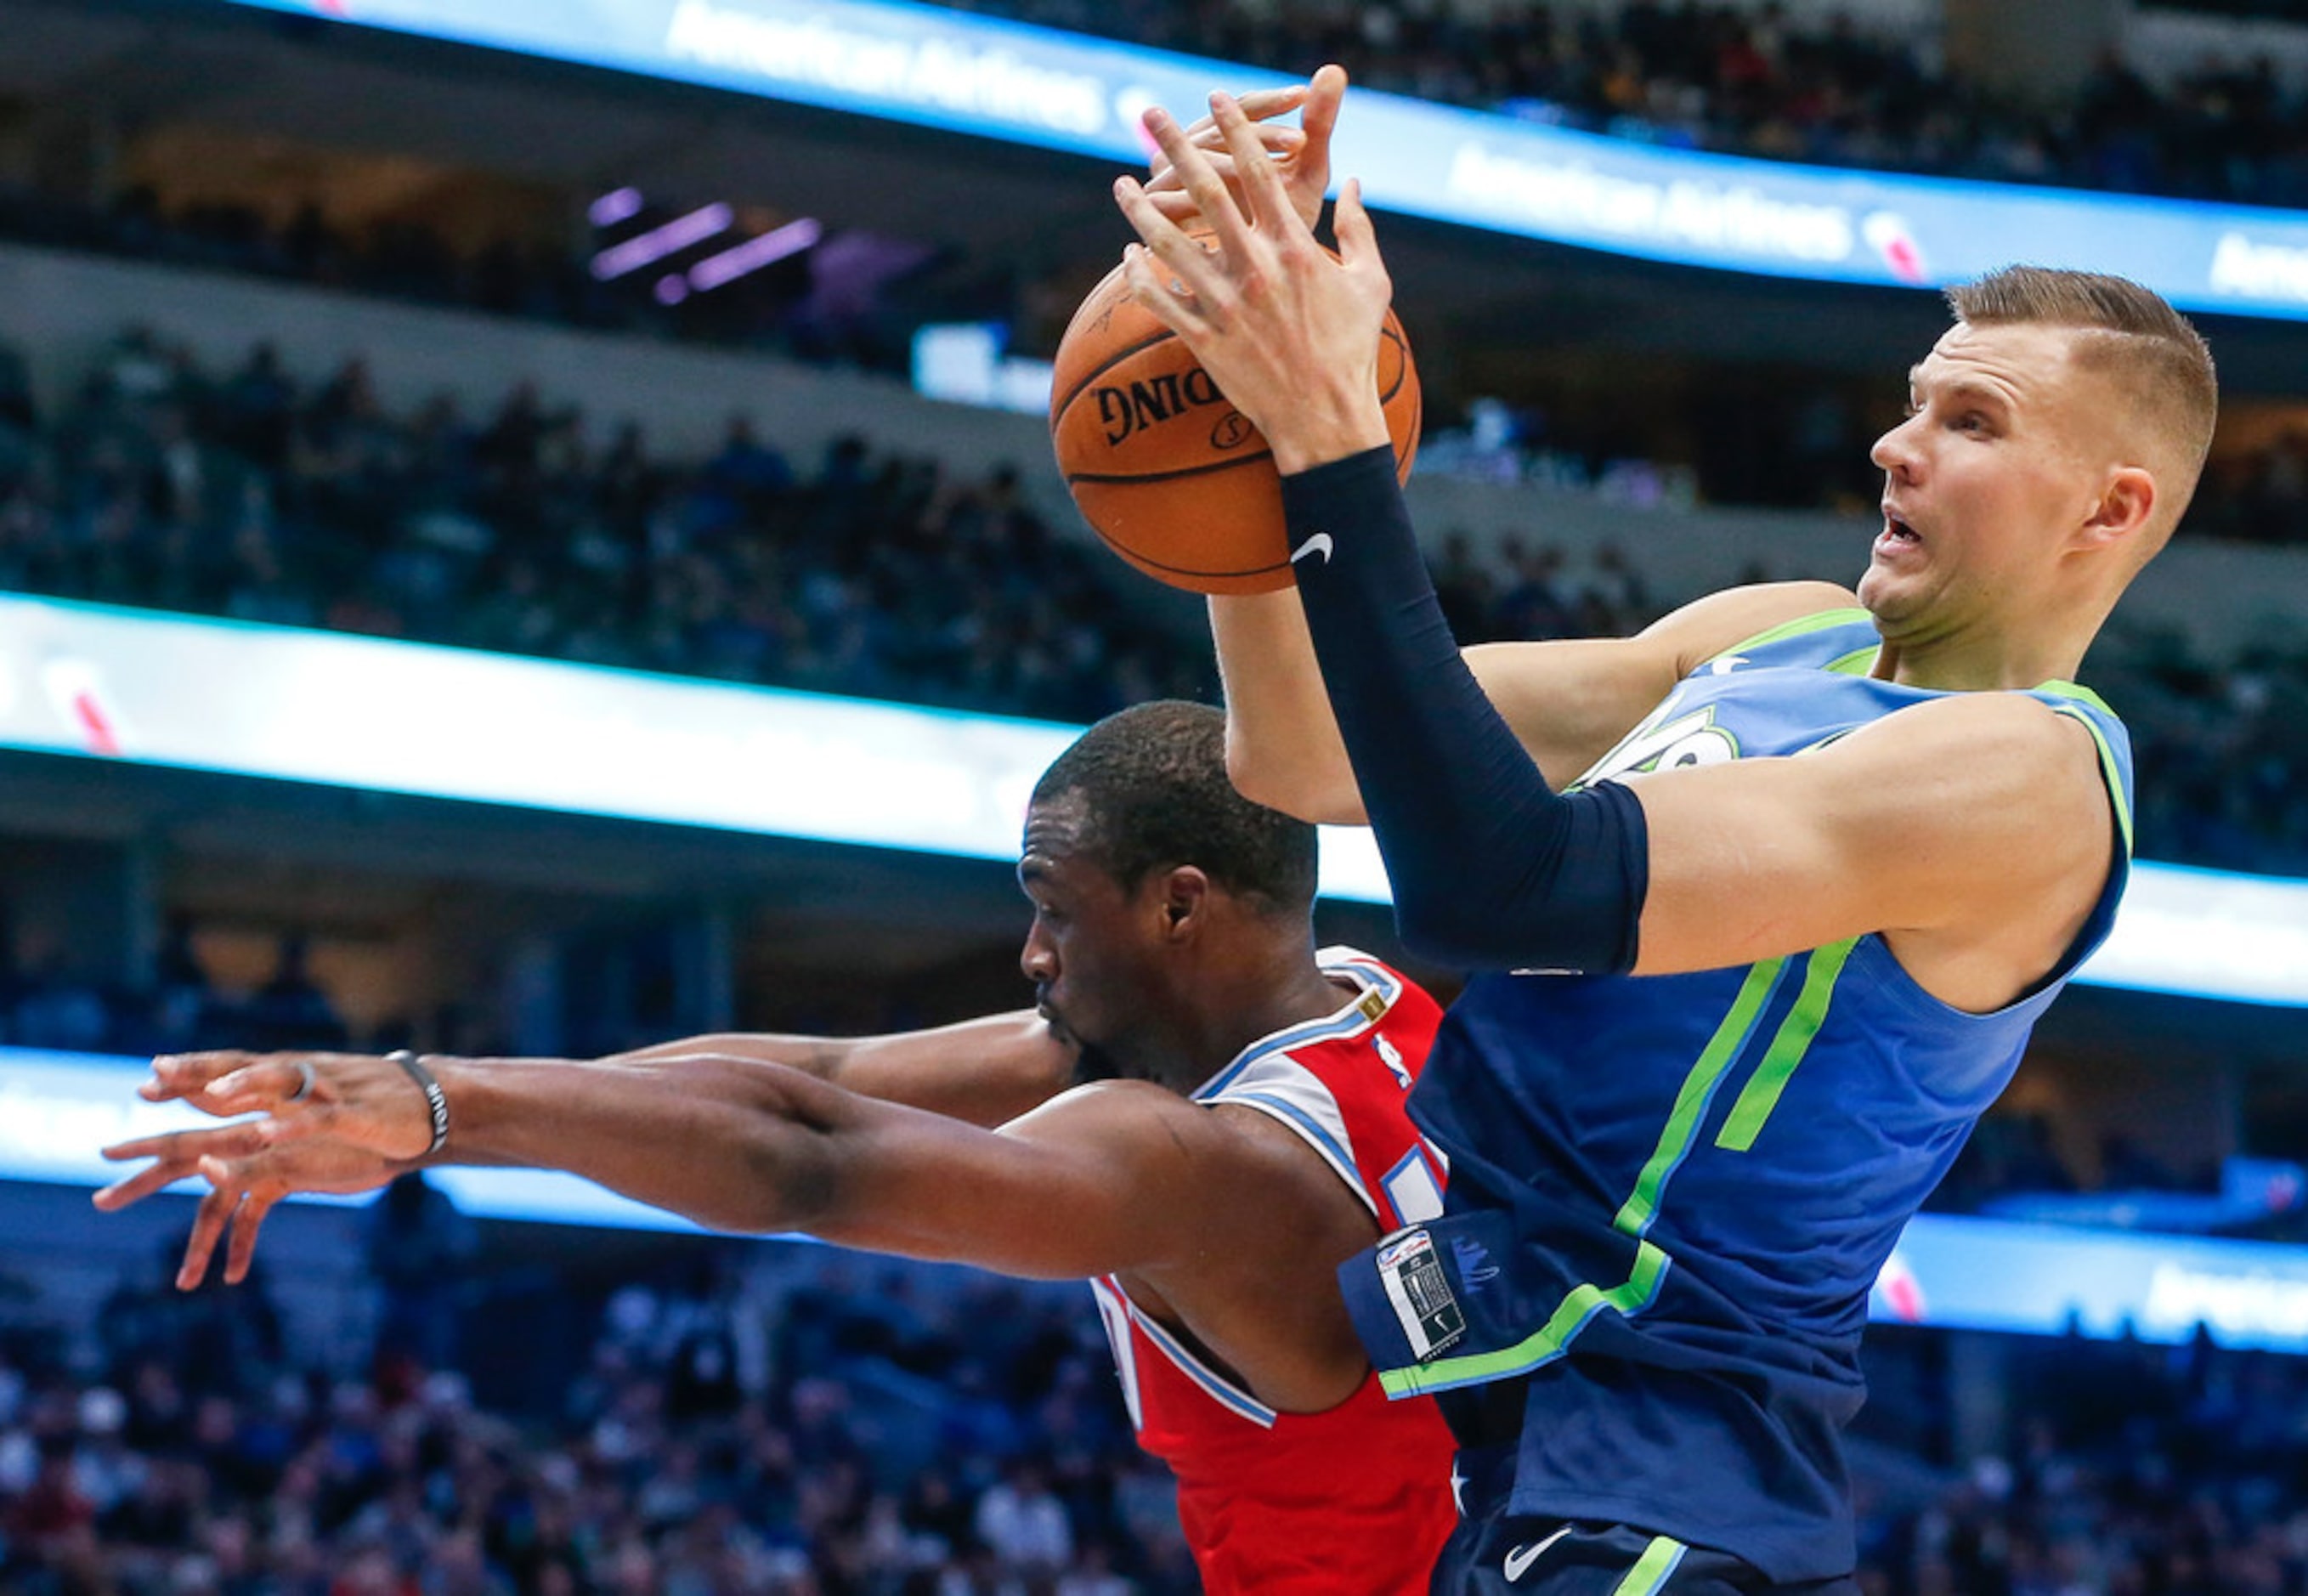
[1050, 266, 1419, 593]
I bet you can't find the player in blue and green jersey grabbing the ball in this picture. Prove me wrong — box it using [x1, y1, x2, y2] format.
[1115, 74, 2215, 1596]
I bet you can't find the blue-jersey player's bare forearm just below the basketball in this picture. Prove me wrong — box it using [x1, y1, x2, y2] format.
[1209, 591, 1366, 824]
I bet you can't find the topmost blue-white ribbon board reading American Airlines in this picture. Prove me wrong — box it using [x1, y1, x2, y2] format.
[217, 0, 2308, 319]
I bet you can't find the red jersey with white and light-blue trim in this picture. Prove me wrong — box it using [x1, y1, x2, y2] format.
[1092, 947, 1457, 1596]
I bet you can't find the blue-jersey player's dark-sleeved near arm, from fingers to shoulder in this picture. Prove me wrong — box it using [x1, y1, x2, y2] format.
[1115, 94, 2112, 1007]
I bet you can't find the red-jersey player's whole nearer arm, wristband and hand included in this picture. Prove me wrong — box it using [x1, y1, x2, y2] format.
[99, 1056, 1366, 1311]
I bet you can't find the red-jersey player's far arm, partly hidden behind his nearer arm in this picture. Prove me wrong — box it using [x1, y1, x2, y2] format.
[602, 1010, 1080, 1127]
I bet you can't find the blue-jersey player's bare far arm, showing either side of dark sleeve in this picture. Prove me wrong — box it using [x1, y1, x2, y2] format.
[1209, 582, 1853, 824]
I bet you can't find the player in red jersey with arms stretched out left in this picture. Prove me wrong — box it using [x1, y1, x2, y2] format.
[97, 702, 1454, 1593]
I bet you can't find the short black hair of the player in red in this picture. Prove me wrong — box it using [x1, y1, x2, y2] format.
[1034, 699, 1318, 914]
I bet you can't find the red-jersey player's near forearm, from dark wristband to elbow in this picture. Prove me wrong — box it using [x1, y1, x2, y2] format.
[429, 1056, 842, 1231]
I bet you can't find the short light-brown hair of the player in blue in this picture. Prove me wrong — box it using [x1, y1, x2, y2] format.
[1948, 266, 2220, 531]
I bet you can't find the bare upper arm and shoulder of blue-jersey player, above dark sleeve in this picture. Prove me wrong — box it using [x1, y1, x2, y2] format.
[1627, 693, 2114, 1011]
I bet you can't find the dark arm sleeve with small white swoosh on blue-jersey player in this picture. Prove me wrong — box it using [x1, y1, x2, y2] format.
[1283, 448, 1650, 972]
